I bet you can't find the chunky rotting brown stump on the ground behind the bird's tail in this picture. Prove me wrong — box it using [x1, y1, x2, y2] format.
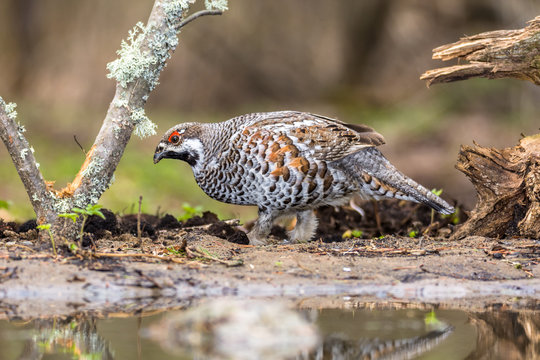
[454, 134, 540, 238]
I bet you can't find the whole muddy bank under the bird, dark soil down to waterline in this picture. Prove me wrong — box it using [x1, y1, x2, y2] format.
[0, 200, 540, 318]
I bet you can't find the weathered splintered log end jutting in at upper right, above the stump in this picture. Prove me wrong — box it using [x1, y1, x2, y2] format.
[420, 16, 540, 86]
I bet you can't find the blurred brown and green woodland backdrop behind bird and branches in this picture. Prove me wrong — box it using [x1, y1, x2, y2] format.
[0, 0, 540, 221]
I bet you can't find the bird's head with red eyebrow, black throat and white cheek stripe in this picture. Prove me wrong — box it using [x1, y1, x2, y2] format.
[154, 123, 204, 167]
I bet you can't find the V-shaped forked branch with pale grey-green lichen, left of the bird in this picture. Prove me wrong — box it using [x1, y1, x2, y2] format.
[0, 0, 227, 240]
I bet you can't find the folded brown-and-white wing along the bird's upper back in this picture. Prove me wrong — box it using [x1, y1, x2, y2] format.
[241, 111, 384, 162]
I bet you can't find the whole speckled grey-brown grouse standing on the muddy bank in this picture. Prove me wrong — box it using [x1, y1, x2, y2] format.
[154, 111, 454, 245]
